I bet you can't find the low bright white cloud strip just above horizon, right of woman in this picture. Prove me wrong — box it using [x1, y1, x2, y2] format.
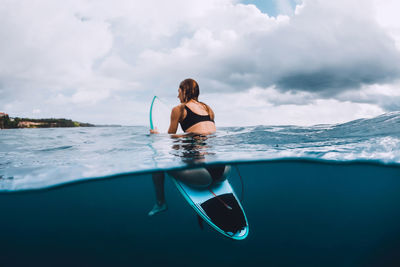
[202, 88, 384, 126]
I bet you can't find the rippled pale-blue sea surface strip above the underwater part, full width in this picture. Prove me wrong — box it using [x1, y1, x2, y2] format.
[0, 112, 400, 191]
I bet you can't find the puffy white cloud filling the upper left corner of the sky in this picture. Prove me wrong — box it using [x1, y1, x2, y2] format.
[0, 1, 112, 85]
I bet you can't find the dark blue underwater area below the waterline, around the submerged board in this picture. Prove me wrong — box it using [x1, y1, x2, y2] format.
[0, 160, 400, 266]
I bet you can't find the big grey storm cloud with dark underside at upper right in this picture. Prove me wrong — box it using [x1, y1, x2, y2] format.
[181, 1, 400, 96]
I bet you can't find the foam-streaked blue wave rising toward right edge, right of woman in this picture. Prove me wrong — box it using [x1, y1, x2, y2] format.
[215, 112, 400, 162]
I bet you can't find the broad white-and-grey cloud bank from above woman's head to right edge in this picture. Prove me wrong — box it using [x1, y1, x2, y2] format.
[118, 0, 400, 96]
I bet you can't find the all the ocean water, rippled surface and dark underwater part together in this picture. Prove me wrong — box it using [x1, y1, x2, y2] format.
[0, 112, 400, 266]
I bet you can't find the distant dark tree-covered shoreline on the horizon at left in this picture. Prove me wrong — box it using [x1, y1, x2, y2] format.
[0, 113, 96, 129]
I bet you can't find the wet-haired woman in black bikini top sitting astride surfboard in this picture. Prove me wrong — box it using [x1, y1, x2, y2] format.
[149, 79, 230, 216]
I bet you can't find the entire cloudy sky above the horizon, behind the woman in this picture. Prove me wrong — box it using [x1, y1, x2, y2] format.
[0, 0, 400, 126]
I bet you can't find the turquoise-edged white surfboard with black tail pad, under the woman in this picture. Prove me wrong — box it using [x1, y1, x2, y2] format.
[150, 96, 249, 240]
